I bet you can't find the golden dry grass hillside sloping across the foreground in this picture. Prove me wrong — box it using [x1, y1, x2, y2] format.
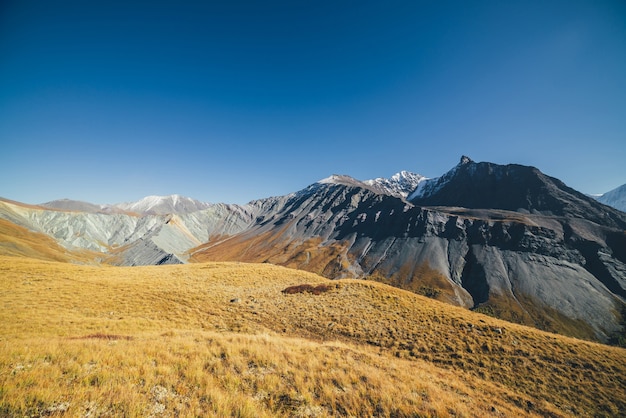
[0, 257, 626, 417]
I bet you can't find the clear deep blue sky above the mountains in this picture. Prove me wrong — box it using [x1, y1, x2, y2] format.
[0, 0, 626, 203]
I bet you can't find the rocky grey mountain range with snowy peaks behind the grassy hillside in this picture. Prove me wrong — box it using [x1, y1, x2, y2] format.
[0, 156, 626, 342]
